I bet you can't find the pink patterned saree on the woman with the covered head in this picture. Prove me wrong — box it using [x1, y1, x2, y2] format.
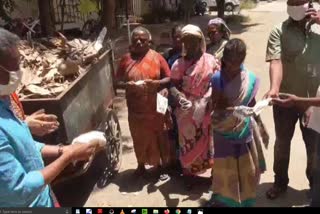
[171, 53, 217, 174]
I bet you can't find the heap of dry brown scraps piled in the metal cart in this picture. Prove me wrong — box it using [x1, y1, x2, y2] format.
[18, 27, 106, 99]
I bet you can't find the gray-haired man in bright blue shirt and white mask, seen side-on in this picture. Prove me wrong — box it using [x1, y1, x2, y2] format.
[0, 28, 96, 207]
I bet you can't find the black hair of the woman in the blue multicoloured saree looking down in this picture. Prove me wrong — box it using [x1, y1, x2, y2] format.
[223, 39, 247, 62]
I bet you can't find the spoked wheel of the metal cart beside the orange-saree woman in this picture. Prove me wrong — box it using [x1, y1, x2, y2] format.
[97, 110, 122, 188]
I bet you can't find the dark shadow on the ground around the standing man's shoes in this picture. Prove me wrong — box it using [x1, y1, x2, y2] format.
[257, 183, 310, 207]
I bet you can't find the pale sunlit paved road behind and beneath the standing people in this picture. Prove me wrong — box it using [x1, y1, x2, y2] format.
[85, 1, 308, 207]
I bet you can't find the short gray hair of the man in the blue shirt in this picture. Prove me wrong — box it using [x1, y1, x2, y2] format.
[0, 28, 20, 60]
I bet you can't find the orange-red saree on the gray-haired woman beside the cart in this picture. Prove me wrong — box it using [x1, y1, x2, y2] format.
[117, 50, 172, 166]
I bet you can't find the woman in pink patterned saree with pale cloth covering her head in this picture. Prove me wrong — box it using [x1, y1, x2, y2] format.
[170, 25, 219, 175]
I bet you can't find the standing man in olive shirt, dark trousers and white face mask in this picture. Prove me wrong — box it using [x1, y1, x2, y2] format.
[265, 0, 320, 199]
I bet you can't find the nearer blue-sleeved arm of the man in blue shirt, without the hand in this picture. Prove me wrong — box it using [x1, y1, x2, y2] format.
[0, 135, 71, 206]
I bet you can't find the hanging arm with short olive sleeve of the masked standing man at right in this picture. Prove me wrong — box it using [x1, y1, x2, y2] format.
[265, 28, 283, 98]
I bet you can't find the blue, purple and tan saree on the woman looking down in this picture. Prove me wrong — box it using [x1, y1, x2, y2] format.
[212, 70, 266, 207]
